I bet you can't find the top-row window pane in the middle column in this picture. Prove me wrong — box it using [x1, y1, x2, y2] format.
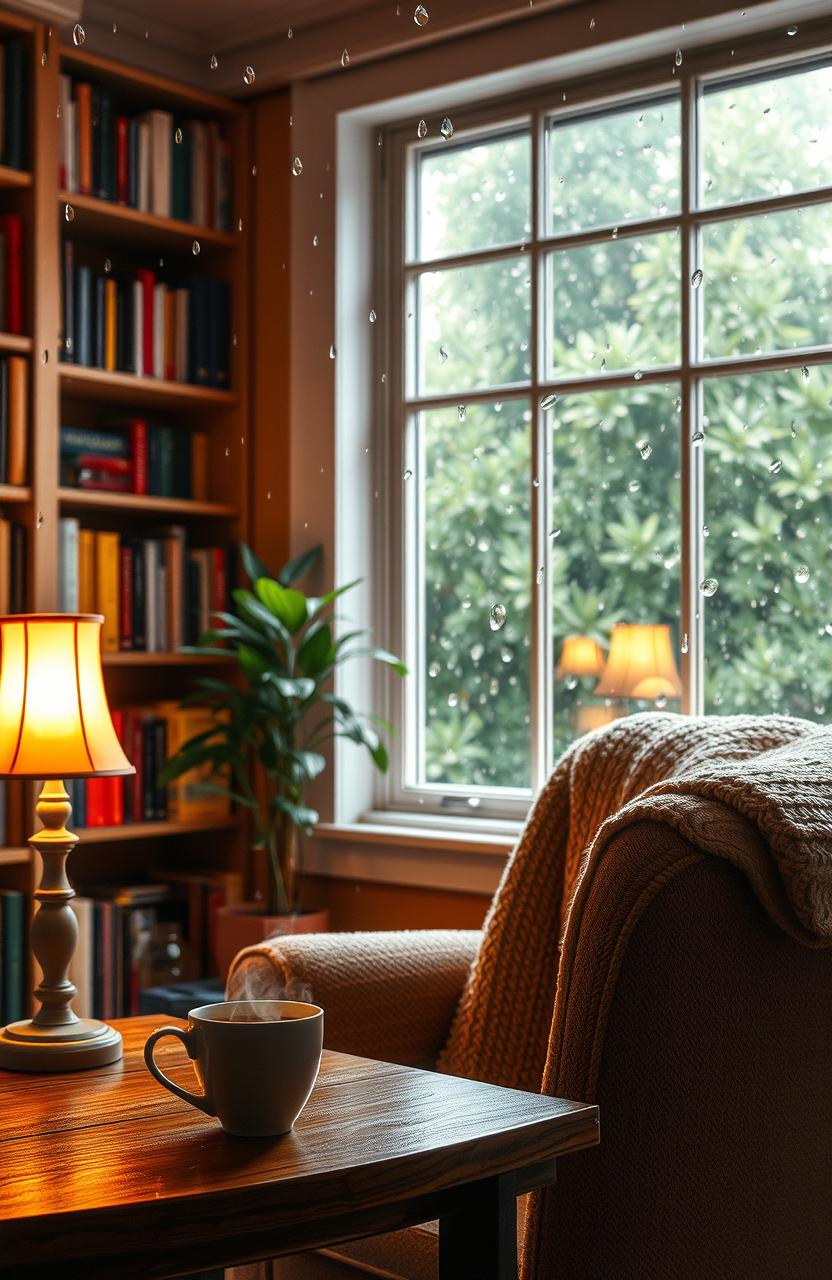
[549, 99, 682, 234]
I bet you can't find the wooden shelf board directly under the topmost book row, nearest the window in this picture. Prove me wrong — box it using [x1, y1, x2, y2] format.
[58, 191, 242, 253]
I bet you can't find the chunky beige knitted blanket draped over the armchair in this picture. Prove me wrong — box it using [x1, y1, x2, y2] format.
[439, 714, 832, 1091]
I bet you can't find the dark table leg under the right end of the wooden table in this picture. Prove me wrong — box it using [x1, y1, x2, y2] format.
[439, 1174, 517, 1280]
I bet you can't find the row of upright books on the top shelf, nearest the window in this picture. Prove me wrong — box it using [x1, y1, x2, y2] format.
[59, 76, 232, 232]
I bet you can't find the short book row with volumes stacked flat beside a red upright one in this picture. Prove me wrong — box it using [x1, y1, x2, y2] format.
[60, 417, 209, 502]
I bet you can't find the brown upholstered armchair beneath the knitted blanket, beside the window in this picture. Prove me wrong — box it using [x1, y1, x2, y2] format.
[229, 718, 832, 1280]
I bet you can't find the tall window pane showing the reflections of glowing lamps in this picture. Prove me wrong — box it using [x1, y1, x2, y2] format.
[549, 384, 681, 754]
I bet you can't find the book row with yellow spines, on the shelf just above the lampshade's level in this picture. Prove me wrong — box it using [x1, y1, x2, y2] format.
[59, 516, 236, 653]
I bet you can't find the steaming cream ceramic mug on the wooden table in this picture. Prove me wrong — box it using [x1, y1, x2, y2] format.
[145, 1000, 324, 1138]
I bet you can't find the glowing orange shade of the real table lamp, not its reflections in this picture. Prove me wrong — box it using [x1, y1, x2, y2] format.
[0, 613, 136, 778]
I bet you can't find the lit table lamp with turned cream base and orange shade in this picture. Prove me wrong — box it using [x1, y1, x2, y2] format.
[0, 613, 134, 1071]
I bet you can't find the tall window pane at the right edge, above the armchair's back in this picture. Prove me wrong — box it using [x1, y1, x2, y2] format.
[701, 367, 832, 719]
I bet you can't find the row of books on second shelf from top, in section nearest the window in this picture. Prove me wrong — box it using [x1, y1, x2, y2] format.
[61, 241, 230, 389]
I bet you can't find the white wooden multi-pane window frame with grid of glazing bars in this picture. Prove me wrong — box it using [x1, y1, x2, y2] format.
[376, 22, 832, 819]
